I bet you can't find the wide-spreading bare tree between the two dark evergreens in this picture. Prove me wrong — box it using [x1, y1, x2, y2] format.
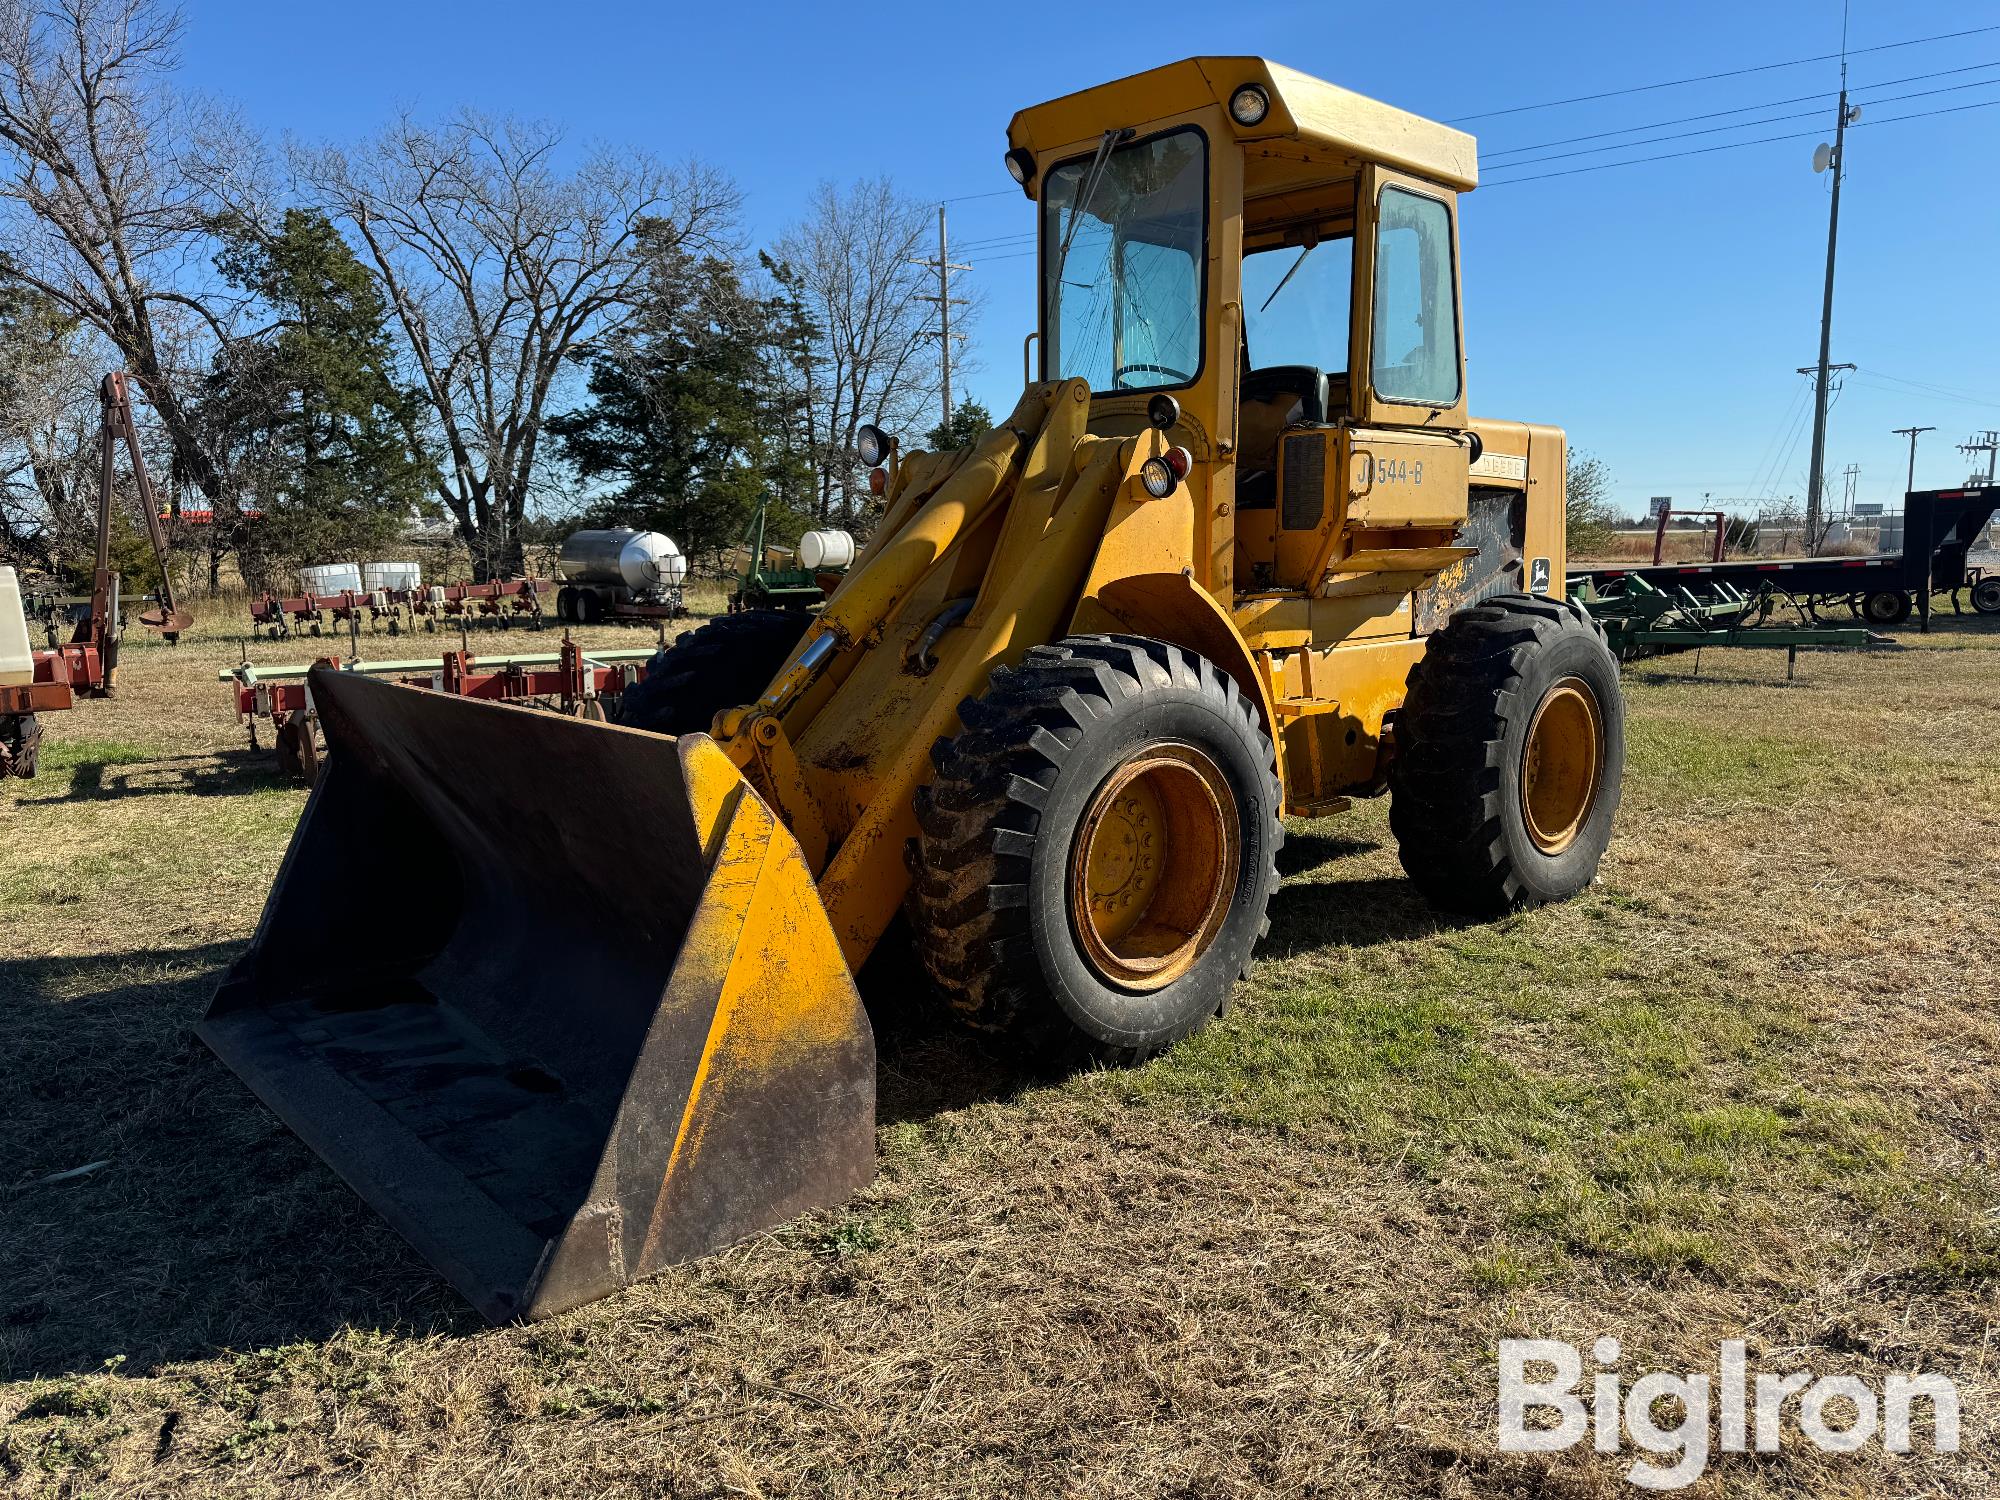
[300, 114, 738, 576]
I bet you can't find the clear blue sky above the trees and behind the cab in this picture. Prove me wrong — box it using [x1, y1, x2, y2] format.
[184, 0, 2000, 508]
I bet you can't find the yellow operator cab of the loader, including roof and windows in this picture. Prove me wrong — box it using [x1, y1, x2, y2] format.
[1008, 58, 1476, 600]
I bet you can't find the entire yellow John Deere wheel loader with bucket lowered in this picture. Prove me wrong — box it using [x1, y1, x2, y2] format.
[202, 58, 1624, 1318]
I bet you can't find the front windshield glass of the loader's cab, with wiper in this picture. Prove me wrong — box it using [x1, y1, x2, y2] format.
[1042, 130, 1206, 390]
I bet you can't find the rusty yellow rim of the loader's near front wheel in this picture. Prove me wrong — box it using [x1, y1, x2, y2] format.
[1070, 744, 1242, 990]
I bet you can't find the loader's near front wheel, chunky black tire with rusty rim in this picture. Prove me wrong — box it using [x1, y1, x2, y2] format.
[906, 636, 1284, 1062]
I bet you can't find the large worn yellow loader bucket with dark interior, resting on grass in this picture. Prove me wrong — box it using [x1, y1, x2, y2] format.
[198, 668, 874, 1322]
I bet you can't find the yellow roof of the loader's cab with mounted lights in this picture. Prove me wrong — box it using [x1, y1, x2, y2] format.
[1008, 58, 1480, 196]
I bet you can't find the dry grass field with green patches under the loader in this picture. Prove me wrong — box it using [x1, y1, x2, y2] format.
[0, 596, 2000, 1500]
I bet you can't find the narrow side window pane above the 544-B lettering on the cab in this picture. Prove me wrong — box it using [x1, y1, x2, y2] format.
[1374, 188, 1458, 406]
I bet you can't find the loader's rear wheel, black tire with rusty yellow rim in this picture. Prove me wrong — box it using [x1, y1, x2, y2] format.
[1388, 594, 1624, 916]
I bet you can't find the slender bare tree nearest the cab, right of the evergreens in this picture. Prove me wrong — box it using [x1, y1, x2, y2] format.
[772, 178, 938, 522]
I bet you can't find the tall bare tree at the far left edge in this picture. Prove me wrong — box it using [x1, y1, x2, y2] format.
[0, 0, 258, 500]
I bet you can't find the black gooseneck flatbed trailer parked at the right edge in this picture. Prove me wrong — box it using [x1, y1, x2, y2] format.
[1568, 486, 2000, 644]
